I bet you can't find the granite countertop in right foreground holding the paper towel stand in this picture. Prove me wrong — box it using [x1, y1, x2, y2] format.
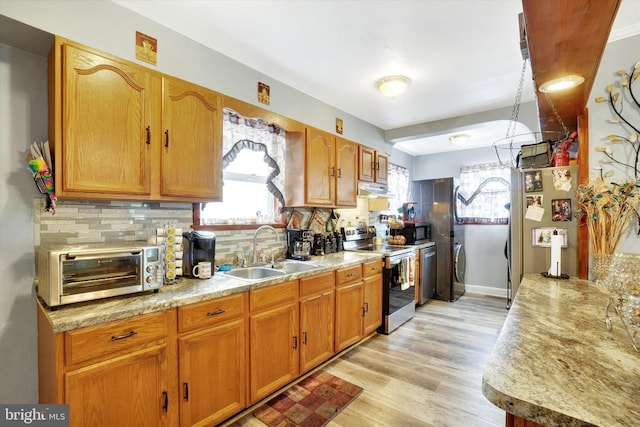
[482, 274, 640, 427]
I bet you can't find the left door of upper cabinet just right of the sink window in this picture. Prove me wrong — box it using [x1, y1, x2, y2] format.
[305, 127, 337, 206]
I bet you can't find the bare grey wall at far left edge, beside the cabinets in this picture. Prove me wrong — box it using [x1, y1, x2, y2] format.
[0, 44, 47, 403]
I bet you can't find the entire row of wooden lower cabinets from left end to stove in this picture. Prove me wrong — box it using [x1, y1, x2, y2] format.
[38, 261, 382, 427]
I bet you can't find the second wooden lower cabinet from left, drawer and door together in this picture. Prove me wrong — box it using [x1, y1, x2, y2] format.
[178, 293, 247, 426]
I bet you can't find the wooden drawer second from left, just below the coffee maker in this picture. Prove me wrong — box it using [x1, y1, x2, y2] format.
[178, 293, 245, 333]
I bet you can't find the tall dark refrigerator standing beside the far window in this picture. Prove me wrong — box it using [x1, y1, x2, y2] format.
[412, 178, 466, 301]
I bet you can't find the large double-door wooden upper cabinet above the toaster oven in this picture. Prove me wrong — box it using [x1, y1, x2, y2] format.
[49, 37, 222, 202]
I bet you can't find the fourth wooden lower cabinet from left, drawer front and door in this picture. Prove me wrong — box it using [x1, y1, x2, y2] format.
[300, 272, 335, 373]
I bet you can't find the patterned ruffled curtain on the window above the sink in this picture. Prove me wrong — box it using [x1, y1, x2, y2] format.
[222, 108, 286, 210]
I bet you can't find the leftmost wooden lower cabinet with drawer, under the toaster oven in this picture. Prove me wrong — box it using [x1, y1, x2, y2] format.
[38, 304, 178, 427]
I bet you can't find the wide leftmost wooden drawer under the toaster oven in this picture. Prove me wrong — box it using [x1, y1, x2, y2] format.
[65, 311, 167, 365]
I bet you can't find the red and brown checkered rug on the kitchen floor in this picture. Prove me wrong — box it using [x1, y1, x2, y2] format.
[253, 370, 362, 427]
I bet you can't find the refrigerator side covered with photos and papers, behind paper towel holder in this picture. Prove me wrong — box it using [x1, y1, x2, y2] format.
[508, 166, 578, 297]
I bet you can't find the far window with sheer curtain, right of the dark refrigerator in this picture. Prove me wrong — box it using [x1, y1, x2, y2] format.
[456, 163, 511, 224]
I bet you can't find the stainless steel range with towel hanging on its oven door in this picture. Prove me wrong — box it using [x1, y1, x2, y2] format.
[342, 227, 416, 334]
